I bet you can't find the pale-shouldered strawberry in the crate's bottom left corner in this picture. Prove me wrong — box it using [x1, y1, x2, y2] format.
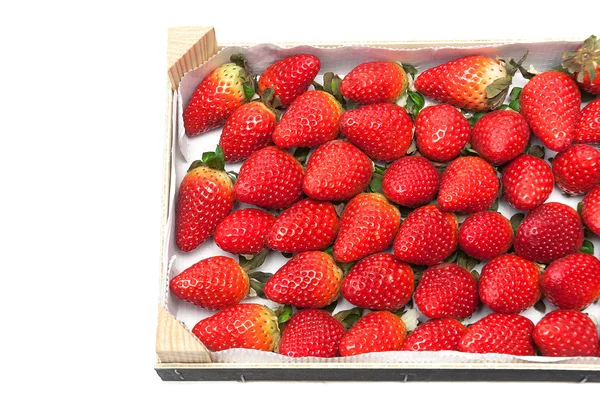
[192, 304, 279, 351]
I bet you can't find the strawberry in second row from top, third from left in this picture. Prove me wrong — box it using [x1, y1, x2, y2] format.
[340, 103, 414, 162]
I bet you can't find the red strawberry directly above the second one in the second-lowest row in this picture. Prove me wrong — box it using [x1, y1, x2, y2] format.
[267, 199, 340, 253]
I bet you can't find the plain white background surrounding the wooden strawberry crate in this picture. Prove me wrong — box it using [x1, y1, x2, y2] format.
[0, 0, 600, 399]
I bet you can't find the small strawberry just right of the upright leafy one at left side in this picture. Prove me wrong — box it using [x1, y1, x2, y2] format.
[215, 208, 275, 254]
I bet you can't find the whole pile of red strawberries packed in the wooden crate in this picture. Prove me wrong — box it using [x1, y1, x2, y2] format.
[170, 36, 600, 357]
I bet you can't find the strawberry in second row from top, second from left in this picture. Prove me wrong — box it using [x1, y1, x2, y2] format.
[273, 90, 343, 148]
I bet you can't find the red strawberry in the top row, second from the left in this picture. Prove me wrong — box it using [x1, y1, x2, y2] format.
[258, 54, 321, 107]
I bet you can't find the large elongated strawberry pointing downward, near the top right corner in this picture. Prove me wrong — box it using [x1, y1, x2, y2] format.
[520, 71, 581, 151]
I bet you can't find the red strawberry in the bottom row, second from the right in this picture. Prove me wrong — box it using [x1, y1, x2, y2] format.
[458, 314, 535, 356]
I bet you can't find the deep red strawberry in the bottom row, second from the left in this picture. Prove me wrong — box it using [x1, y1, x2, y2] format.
[279, 309, 346, 357]
